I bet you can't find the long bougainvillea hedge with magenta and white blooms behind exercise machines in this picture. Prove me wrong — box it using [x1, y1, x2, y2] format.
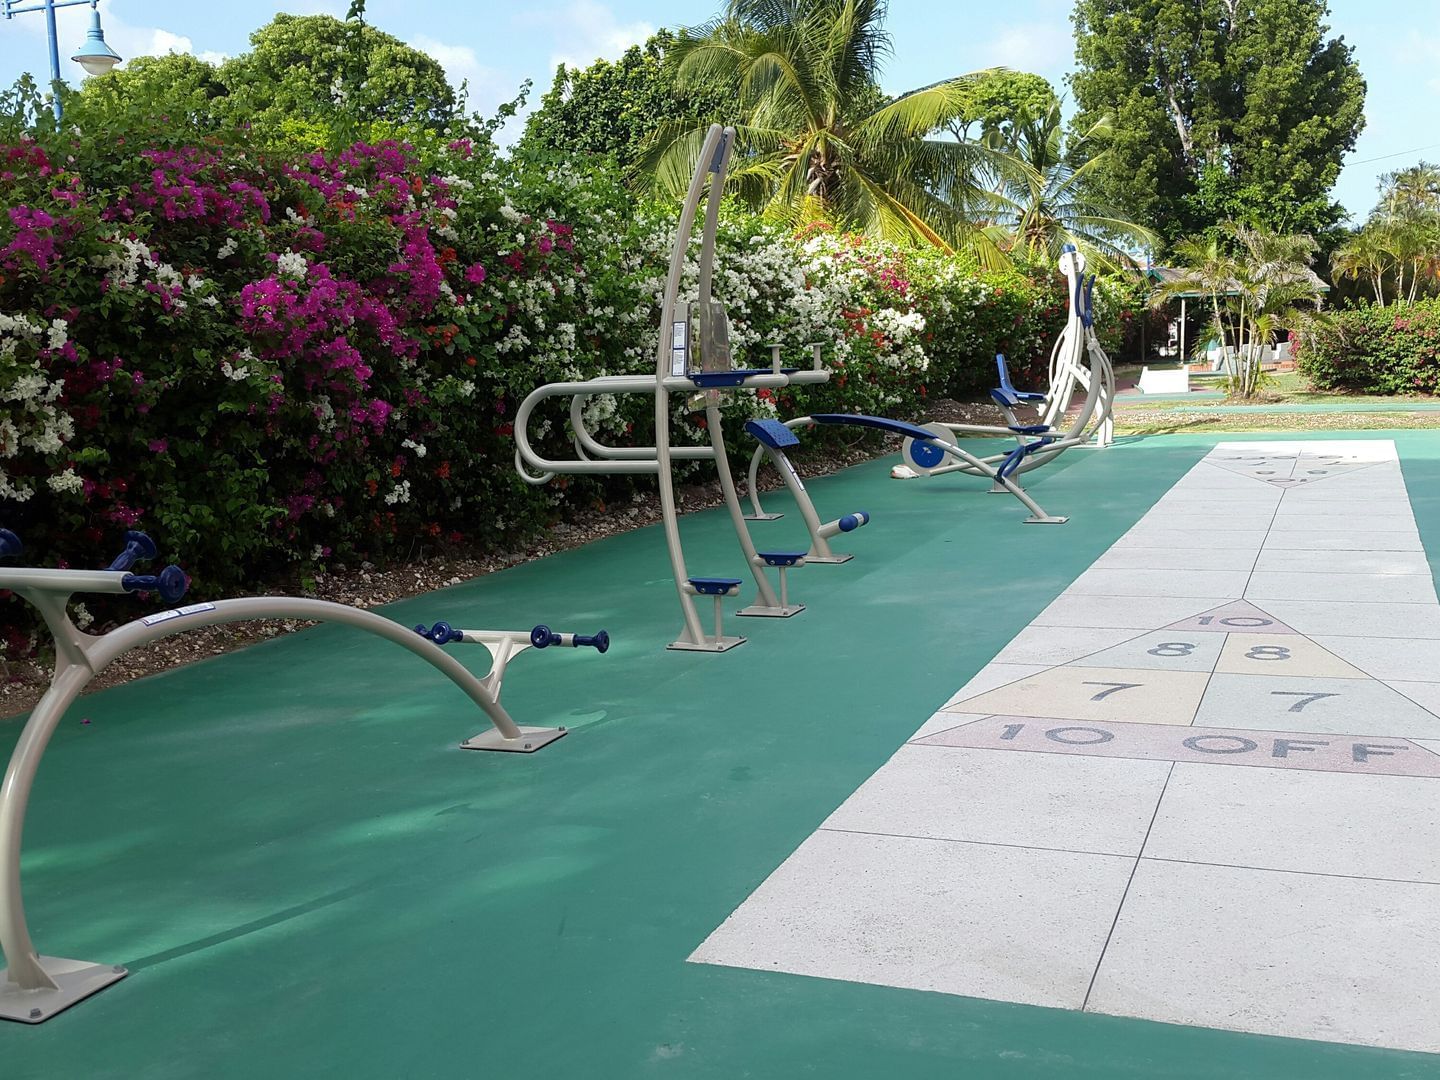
[0, 112, 1088, 642]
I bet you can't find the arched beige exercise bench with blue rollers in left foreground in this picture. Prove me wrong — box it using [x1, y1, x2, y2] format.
[0, 528, 609, 1024]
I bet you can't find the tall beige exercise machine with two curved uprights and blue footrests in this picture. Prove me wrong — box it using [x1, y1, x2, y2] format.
[514, 124, 829, 652]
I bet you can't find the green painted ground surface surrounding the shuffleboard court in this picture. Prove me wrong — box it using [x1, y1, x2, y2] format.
[0, 432, 1440, 1080]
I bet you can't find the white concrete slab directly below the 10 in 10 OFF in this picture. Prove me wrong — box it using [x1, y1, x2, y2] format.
[821, 744, 1175, 855]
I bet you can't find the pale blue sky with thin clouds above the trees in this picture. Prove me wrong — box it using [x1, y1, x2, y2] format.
[0, 0, 1440, 219]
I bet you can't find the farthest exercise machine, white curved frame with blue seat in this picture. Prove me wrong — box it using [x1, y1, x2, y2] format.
[896, 243, 1115, 491]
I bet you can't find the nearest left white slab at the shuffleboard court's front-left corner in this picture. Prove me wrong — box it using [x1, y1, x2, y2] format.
[690, 829, 1135, 1009]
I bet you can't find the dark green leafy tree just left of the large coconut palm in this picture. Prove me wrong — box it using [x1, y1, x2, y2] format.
[516, 30, 733, 168]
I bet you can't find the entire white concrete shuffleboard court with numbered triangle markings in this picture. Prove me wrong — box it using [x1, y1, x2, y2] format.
[691, 439, 1440, 1053]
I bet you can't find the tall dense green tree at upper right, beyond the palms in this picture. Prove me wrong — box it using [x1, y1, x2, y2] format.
[1071, 0, 1365, 240]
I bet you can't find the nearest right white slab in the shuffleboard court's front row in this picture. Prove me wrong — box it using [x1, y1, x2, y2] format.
[1089, 860, 1440, 1053]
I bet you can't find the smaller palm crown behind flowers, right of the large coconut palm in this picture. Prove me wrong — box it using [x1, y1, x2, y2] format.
[995, 102, 1158, 269]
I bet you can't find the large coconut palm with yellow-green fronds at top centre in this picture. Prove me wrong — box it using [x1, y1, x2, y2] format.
[644, 0, 1004, 264]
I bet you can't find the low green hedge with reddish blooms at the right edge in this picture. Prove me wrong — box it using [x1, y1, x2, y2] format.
[1296, 300, 1440, 393]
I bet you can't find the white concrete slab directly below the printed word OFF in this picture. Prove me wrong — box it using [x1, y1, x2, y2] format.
[1145, 766, 1440, 884]
